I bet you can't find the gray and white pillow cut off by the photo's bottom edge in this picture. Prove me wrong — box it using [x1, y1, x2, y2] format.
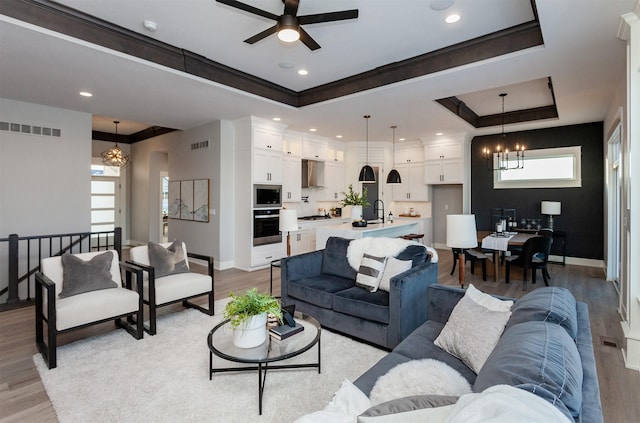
[358, 395, 458, 423]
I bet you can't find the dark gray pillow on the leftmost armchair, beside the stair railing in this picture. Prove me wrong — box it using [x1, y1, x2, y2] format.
[58, 251, 118, 298]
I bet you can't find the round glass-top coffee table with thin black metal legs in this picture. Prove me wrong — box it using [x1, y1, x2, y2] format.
[207, 312, 321, 414]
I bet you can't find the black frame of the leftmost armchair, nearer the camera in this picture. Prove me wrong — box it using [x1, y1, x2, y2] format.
[35, 262, 144, 369]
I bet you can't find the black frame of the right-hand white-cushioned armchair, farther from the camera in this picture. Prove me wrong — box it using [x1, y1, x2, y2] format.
[127, 252, 215, 335]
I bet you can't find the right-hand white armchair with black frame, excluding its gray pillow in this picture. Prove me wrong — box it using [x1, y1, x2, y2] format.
[128, 242, 214, 335]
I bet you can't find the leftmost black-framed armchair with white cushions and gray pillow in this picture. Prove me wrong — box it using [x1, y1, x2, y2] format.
[35, 250, 143, 369]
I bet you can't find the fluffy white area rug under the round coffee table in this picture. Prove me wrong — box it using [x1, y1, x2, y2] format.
[33, 302, 386, 423]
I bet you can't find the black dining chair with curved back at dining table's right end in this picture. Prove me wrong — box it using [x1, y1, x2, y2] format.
[505, 236, 551, 291]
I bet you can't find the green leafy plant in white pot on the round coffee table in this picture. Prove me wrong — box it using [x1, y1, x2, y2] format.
[224, 288, 282, 348]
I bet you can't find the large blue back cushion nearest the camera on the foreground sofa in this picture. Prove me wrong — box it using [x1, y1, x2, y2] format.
[473, 322, 583, 421]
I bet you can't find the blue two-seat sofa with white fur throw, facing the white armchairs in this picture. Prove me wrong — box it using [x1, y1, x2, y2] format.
[281, 237, 438, 350]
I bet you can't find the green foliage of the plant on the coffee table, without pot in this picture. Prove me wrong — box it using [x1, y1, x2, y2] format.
[224, 288, 282, 329]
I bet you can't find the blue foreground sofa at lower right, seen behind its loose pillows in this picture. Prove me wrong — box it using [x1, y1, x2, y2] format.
[354, 285, 603, 423]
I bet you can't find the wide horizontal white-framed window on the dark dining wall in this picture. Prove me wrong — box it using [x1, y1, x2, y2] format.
[493, 146, 582, 189]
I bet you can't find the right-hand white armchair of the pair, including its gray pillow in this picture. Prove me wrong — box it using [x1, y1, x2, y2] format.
[128, 241, 214, 335]
